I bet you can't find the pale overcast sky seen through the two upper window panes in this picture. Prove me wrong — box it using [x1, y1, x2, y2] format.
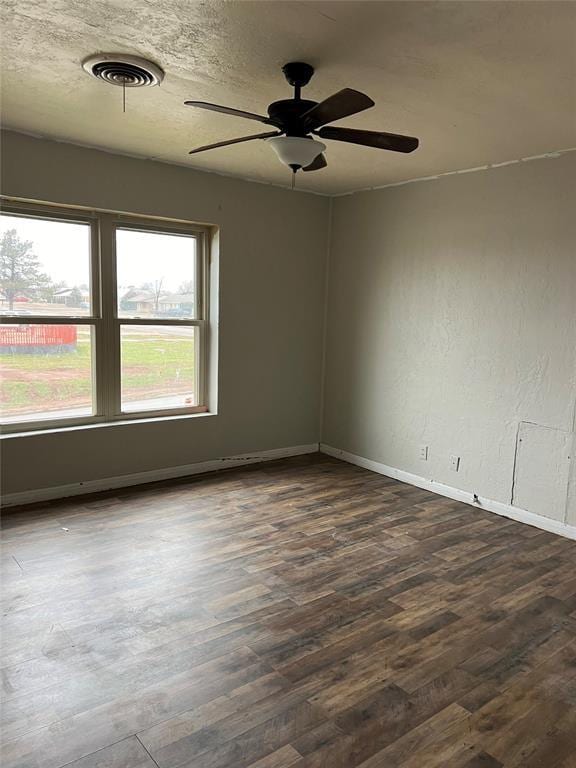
[0, 214, 195, 292]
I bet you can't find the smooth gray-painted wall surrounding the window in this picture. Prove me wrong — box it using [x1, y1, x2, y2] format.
[1, 132, 329, 493]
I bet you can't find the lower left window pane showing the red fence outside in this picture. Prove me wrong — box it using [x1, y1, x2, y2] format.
[0, 325, 93, 423]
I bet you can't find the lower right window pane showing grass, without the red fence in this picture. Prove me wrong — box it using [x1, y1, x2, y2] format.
[120, 325, 198, 411]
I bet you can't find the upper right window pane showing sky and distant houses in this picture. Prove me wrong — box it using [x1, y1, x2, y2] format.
[116, 229, 196, 318]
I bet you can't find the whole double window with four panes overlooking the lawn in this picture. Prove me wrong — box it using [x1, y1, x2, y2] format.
[0, 205, 208, 431]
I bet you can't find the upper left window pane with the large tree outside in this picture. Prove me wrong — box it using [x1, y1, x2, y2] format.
[0, 213, 90, 317]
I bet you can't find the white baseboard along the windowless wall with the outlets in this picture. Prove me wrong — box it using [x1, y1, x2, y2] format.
[320, 443, 576, 539]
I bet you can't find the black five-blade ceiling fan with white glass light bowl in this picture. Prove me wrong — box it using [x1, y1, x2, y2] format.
[184, 61, 418, 173]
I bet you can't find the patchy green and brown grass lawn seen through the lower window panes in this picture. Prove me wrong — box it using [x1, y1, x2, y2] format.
[0, 328, 194, 416]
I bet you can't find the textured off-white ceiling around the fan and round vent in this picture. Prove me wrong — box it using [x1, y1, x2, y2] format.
[2, 0, 576, 193]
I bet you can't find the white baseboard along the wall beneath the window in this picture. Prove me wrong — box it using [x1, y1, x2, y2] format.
[2, 443, 319, 507]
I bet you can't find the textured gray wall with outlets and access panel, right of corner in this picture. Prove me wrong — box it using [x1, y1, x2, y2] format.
[322, 153, 576, 523]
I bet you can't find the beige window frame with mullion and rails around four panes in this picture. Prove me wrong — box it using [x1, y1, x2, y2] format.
[0, 199, 211, 435]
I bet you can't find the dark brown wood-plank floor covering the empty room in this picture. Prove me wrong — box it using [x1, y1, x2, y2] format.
[2, 457, 576, 768]
